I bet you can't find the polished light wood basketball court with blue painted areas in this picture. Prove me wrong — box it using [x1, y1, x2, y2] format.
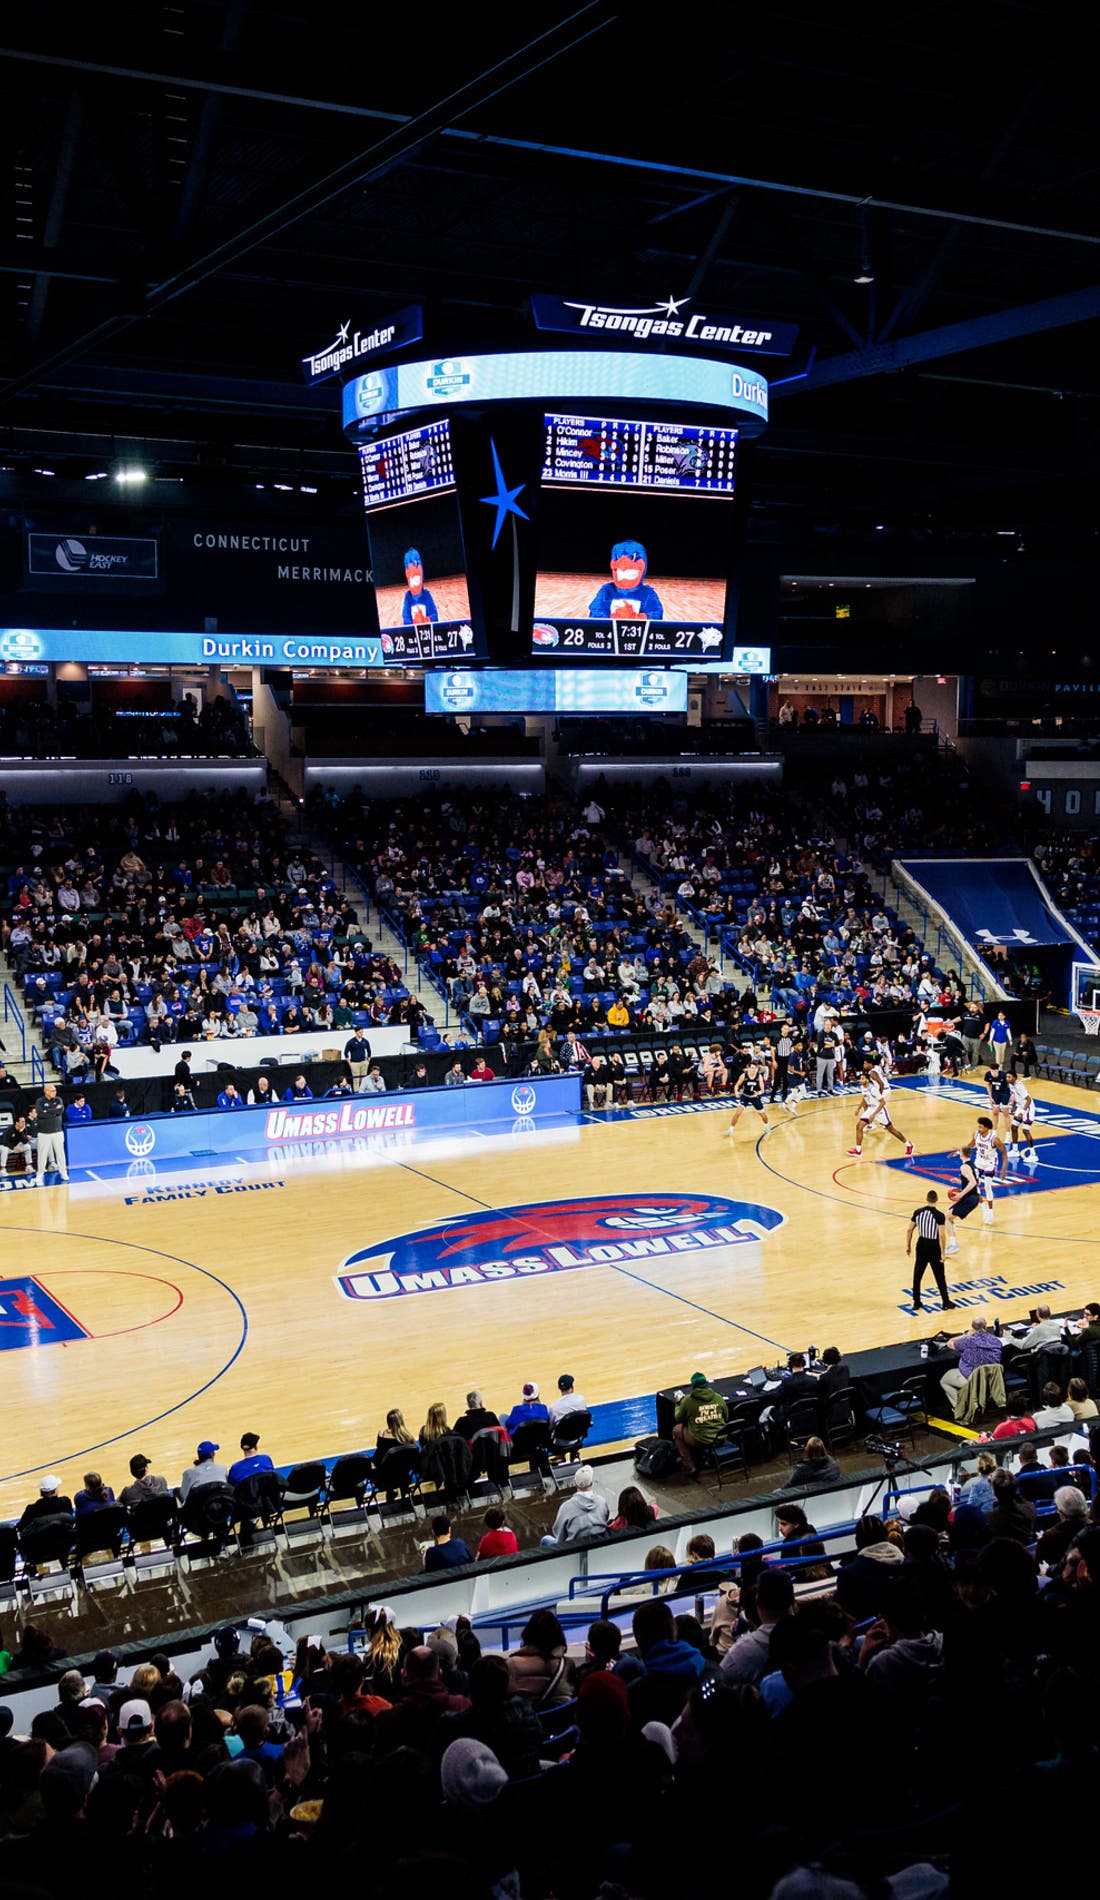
[0, 1079, 1100, 1516]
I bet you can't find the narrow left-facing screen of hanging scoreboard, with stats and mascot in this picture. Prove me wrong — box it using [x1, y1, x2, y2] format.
[359, 418, 483, 663]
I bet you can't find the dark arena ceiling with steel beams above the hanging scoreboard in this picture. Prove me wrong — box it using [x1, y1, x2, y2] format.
[0, 0, 1100, 553]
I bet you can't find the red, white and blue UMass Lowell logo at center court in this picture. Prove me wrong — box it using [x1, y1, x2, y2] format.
[336, 1193, 783, 1300]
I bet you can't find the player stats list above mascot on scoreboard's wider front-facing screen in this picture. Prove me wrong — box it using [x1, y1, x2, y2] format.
[541, 416, 737, 494]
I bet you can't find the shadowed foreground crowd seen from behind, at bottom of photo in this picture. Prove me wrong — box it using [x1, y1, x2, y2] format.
[10, 1421, 1100, 1900]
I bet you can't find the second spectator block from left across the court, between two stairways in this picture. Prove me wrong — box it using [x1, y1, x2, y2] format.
[317, 790, 756, 1047]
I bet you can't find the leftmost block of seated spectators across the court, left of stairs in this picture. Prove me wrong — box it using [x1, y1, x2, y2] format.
[0, 794, 435, 1079]
